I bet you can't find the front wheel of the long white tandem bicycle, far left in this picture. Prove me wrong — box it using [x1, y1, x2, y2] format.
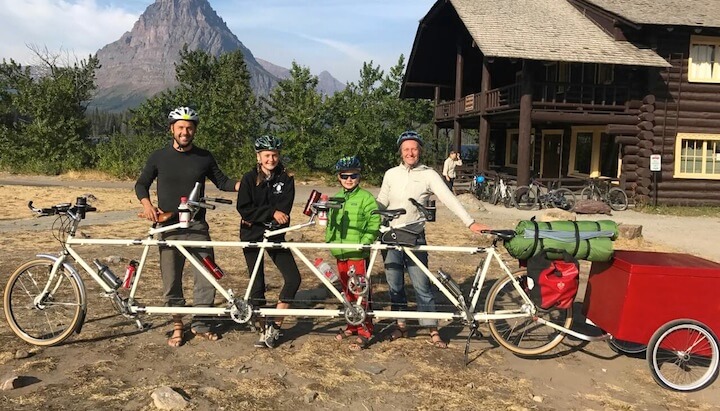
[3, 260, 82, 346]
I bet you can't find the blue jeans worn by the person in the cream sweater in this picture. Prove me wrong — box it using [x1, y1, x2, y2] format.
[385, 235, 437, 327]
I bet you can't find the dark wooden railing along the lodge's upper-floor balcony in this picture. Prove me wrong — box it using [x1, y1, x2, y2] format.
[435, 83, 630, 120]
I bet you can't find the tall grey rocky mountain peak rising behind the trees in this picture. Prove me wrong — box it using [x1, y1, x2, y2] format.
[95, 0, 277, 110]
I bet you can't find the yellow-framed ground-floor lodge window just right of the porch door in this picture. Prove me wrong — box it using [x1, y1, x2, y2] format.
[569, 127, 620, 178]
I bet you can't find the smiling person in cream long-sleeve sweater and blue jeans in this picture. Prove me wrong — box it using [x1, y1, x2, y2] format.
[377, 131, 489, 348]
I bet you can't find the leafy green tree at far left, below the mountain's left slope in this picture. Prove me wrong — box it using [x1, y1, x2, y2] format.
[0, 50, 99, 173]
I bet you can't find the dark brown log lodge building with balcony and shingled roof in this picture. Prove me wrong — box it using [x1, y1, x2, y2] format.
[401, 0, 720, 205]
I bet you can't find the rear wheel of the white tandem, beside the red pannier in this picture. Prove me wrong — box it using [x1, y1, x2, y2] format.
[485, 269, 572, 356]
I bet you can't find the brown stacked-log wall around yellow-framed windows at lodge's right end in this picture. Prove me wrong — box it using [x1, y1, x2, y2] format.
[620, 29, 720, 206]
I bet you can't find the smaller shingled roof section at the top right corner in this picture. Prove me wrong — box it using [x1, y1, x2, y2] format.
[584, 0, 720, 27]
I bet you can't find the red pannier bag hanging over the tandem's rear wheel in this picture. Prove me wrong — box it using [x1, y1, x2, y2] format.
[526, 249, 580, 310]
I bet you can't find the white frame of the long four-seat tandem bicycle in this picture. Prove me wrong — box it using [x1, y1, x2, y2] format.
[39, 209, 531, 328]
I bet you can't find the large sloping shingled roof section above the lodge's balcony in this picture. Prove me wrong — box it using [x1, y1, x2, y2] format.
[456, 0, 668, 67]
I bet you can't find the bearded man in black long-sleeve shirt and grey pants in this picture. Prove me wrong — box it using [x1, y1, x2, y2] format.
[135, 107, 240, 347]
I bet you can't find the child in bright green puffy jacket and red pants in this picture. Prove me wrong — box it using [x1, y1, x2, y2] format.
[325, 156, 380, 350]
